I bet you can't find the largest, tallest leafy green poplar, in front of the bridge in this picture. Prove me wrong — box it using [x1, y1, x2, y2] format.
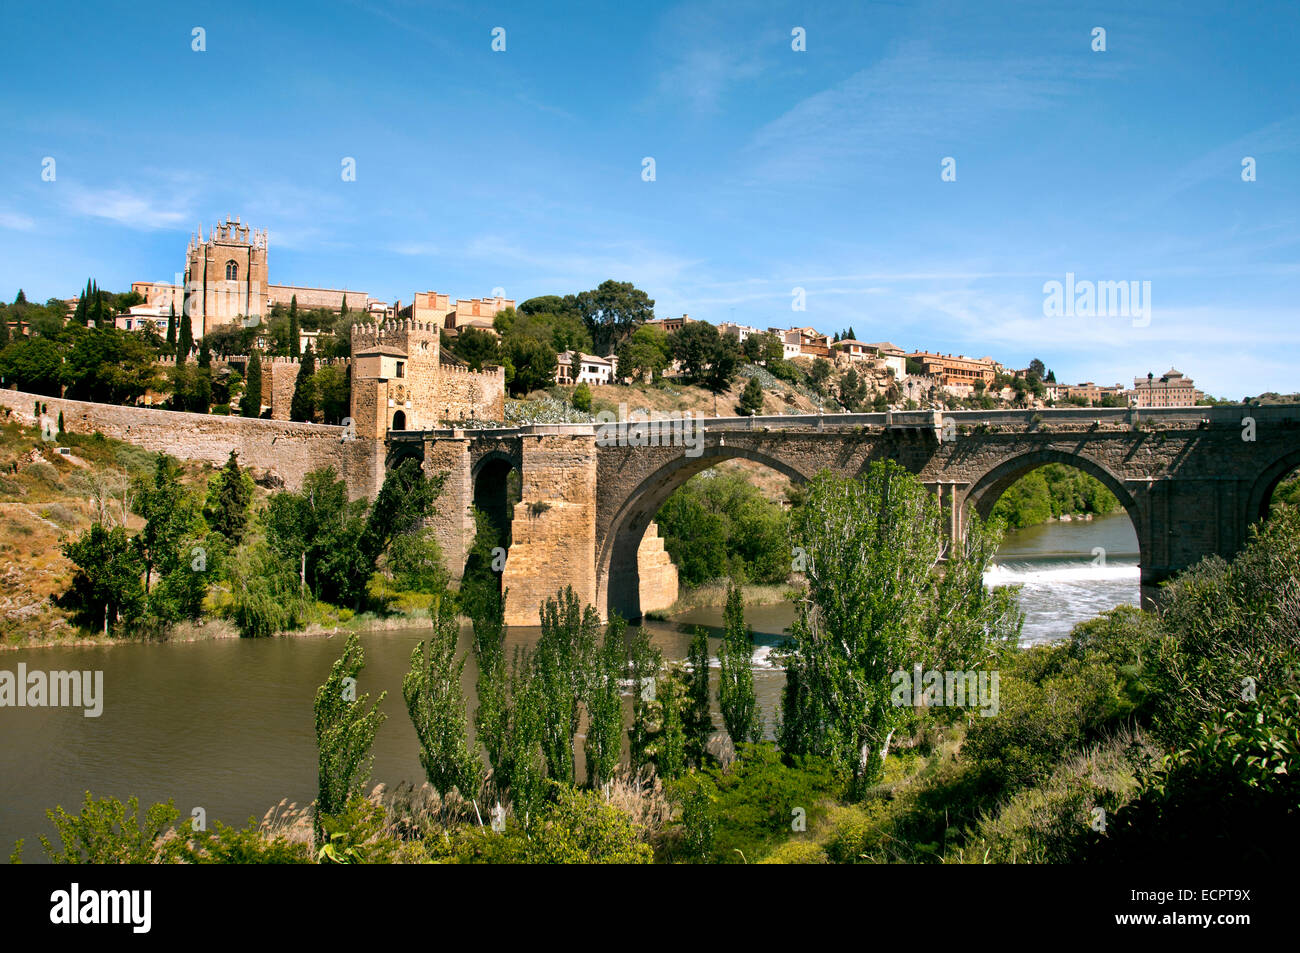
[781, 462, 1019, 794]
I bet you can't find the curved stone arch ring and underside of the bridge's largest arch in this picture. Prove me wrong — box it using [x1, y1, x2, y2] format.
[595, 441, 809, 619]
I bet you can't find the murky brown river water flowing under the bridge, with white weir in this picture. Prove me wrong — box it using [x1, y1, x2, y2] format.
[0, 514, 1139, 862]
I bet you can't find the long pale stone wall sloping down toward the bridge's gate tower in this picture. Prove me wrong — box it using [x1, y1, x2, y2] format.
[0, 390, 384, 499]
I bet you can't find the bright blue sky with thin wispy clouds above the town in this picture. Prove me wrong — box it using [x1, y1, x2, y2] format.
[0, 0, 1300, 398]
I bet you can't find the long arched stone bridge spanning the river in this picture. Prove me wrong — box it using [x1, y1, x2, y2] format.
[386, 406, 1300, 625]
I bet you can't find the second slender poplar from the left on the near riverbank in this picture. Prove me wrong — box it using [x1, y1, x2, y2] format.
[402, 594, 478, 798]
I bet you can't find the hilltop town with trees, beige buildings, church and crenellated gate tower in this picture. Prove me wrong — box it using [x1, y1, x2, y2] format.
[0, 217, 1210, 438]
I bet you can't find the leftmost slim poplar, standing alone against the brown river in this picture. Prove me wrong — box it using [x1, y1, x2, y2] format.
[313, 632, 387, 841]
